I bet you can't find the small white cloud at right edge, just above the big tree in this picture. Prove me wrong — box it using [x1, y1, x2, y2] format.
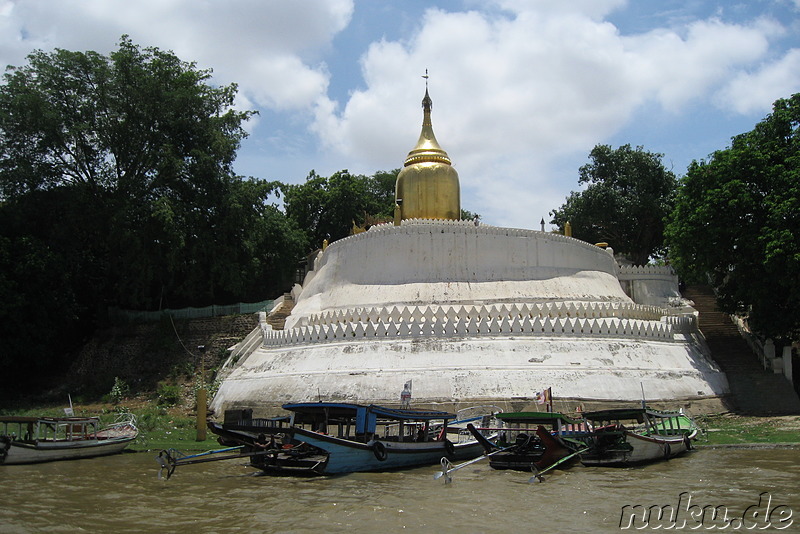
[718, 48, 800, 114]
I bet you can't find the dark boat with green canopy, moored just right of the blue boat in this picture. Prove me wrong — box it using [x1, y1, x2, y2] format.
[471, 412, 587, 473]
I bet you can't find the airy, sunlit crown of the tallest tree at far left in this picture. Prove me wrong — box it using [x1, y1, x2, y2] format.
[0, 37, 251, 200]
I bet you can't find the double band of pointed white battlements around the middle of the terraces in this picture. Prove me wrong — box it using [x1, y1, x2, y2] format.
[263, 302, 697, 347]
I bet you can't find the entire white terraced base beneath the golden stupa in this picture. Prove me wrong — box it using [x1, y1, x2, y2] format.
[212, 220, 728, 413]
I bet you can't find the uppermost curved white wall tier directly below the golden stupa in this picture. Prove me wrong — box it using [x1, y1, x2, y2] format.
[287, 220, 630, 327]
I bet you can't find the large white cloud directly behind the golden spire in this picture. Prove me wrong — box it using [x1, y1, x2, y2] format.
[314, 1, 777, 227]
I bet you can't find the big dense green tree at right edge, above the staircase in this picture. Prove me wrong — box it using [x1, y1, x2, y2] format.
[666, 93, 800, 340]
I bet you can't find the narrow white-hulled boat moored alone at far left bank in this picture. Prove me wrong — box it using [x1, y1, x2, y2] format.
[0, 414, 139, 465]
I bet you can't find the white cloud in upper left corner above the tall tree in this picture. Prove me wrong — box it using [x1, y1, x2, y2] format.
[0, 0, 353, 113]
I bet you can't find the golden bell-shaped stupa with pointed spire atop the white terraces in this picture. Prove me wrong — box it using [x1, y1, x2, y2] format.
[395, 87, 461, 224]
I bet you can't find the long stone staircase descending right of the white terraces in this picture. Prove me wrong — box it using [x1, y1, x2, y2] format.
[683, 286, 800, 415]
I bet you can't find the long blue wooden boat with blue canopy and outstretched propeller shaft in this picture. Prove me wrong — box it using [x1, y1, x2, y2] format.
[159, 402, 494, 476]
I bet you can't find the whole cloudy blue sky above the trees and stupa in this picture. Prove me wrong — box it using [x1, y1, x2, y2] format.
[0, 0, 800, 229]
